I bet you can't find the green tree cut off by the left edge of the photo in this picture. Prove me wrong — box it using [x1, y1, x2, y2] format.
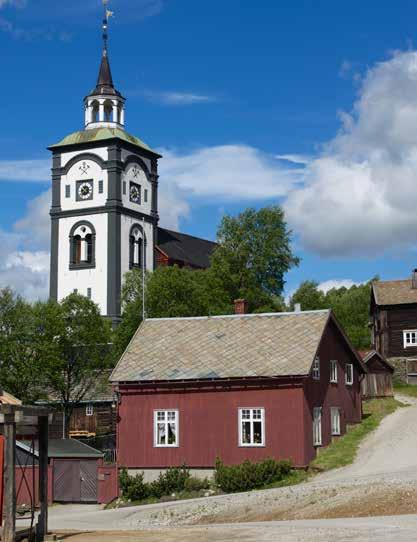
[0, 288, 46, 403]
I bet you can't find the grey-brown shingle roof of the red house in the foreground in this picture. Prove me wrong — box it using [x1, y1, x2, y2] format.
[110, 310, 330, 382]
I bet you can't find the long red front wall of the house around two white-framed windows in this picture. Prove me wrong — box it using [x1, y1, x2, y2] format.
[118, 384, 306, 468]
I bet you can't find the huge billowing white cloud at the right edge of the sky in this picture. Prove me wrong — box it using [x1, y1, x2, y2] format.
[285, 52, 417, 257]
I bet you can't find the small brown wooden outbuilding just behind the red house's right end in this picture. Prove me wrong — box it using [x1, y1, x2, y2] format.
[359, 350, 394, 399]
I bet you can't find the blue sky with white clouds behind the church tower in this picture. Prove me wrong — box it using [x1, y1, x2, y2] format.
[0, 0, 417, 300]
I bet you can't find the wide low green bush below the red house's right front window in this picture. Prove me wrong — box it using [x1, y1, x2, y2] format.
[215, 458, 291, 493]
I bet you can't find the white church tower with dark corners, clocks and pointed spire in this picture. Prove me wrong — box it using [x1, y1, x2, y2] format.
[49, 11, 161, 325]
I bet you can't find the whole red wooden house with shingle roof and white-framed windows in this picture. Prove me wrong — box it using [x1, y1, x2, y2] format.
[111, 310, 366, 479]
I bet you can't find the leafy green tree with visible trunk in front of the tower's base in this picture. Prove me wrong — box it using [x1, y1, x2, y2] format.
[38, 293, 111, 434]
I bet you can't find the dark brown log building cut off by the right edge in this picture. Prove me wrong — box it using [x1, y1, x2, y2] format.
[370, 270, 417, 384]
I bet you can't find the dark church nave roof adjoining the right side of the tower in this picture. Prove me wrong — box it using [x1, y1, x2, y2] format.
[158, 228, 217, 269]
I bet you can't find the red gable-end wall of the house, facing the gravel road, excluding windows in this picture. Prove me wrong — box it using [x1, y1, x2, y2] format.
[304, 322, 362, 462]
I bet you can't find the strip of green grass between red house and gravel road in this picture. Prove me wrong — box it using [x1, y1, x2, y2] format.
[310, 397, 405, 471]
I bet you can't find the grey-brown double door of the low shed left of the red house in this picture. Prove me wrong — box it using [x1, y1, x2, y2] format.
[54, 459, 97, 502]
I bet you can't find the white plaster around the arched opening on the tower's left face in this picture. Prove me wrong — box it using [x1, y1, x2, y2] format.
[58, 213, 108, 315]
